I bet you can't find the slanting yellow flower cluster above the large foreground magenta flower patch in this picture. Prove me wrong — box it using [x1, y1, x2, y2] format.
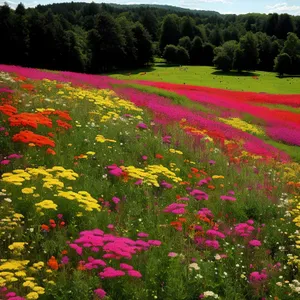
[58, 191, 101, 211]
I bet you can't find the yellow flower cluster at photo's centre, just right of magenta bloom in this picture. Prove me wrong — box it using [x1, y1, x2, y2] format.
[121, 165, 182, 187]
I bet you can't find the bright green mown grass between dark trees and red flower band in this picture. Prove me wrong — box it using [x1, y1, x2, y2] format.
[110, 65, 300, 94]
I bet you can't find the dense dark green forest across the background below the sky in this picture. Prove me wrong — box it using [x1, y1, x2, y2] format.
[0, 2, 300, 75]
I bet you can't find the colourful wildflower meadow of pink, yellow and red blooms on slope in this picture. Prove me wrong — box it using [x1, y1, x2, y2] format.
[0, 65, 300, 300]
